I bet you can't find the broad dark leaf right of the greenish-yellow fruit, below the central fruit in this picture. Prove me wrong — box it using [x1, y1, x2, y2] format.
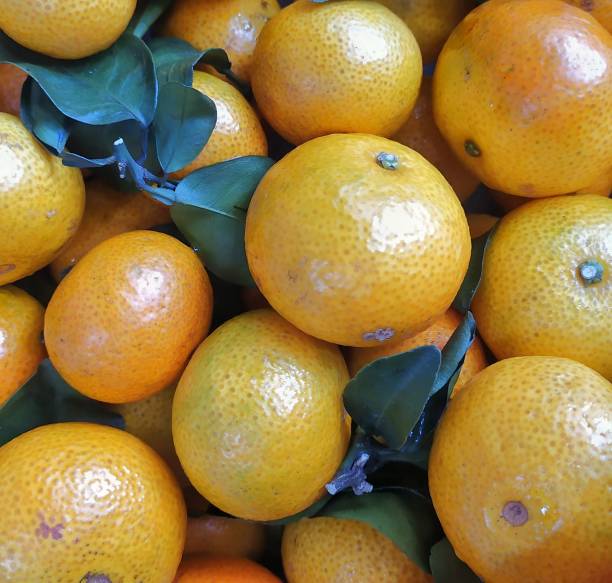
[344, 346, 441, 449]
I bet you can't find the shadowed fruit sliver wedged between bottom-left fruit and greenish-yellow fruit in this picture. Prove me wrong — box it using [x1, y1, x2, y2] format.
[113, 385, 188, 484]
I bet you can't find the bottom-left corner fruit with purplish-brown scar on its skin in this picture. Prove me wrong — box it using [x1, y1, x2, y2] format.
[0, 423, 186, 583]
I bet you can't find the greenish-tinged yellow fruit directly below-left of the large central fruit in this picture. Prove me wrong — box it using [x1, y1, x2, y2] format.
[172, 310, 350, 520]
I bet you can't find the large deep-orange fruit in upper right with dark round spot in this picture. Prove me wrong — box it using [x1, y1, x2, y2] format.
[433, 0, 612, 197]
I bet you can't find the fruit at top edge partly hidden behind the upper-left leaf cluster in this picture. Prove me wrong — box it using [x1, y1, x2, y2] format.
[164, 0, 280, 81]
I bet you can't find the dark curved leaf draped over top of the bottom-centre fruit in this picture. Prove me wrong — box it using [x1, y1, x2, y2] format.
[319, 491, 440, 573]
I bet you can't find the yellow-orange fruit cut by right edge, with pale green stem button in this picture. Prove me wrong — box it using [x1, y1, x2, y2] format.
[472, 195, 612, 379]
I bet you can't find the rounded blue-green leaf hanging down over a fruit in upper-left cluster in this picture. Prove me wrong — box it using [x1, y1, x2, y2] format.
[153, 83, 217, 174]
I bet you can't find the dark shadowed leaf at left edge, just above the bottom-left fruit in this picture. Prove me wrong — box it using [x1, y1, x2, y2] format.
[0, 359, 124, 445]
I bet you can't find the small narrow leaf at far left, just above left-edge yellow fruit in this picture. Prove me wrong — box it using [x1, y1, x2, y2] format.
[21, 77, 70, 155]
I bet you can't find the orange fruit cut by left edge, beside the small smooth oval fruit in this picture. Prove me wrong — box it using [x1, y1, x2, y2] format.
[0, 285, 45, 406]
